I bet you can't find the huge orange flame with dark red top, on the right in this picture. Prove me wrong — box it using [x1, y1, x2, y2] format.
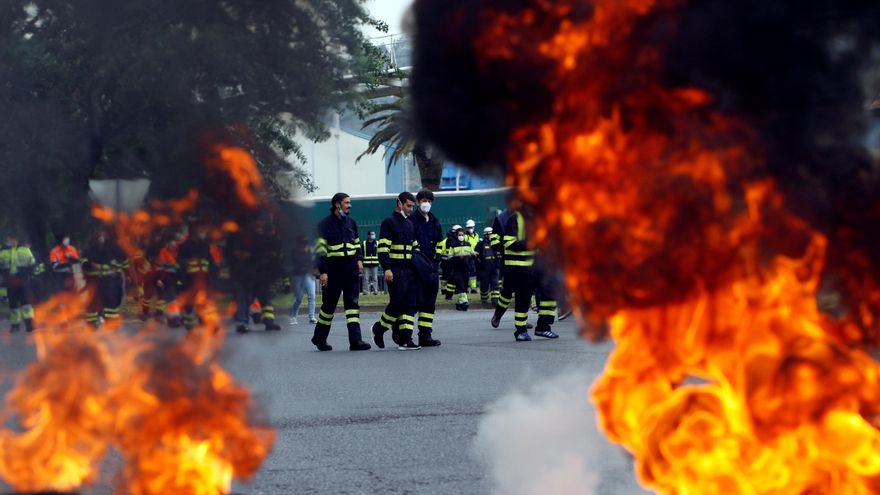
[474, 0, 880, 494]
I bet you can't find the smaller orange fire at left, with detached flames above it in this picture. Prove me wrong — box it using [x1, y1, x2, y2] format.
[0, 148, 275, 495]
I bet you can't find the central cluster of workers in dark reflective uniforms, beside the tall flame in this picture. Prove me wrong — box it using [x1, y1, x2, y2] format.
[311, 190, 558, 351]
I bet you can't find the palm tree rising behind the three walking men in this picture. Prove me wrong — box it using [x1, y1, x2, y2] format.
[357, 96, 443, 191]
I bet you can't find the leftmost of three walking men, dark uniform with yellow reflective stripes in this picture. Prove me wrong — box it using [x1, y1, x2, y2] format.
[312, 192, 370, 351]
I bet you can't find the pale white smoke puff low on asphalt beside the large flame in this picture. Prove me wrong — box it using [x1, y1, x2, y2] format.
[474, 370, 642, 495]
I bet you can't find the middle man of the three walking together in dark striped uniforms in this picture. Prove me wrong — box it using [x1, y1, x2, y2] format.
[372, 192, 421, 351]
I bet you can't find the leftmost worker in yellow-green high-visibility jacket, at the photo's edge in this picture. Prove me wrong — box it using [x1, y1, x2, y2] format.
[0, 233, 37, 332]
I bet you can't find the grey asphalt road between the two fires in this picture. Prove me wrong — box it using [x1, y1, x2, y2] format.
[0, 310, 648, 495]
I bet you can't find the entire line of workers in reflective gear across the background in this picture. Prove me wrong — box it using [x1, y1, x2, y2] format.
[0, 190, 558, 351]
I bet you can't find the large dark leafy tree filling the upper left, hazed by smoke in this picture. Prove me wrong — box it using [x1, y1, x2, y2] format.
[0, 0, 383, 244]
